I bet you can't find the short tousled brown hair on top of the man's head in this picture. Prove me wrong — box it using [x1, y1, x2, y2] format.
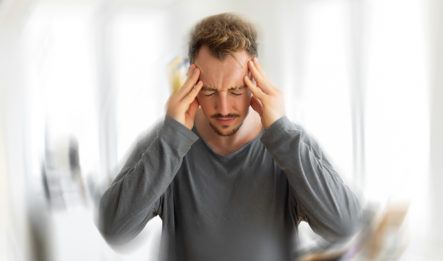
[188, 13, 257, 63]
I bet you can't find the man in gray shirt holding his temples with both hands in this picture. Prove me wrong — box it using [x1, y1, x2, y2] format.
[100, 14, 360, 261]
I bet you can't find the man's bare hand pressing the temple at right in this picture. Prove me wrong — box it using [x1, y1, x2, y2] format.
[244, 57, 285, 129]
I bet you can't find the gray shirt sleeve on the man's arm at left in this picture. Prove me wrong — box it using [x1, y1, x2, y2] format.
[98, 116, 198, 244]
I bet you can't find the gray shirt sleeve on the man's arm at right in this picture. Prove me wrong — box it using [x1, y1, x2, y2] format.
[261, 116, 362, 241]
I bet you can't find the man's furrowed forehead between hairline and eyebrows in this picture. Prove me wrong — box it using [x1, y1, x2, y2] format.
[195, 46, 250, 90]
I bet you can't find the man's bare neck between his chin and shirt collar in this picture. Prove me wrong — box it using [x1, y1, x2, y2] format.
[195, 109, 262, 155]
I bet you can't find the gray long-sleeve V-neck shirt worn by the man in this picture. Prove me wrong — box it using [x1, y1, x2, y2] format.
[99, 116, 361, 261]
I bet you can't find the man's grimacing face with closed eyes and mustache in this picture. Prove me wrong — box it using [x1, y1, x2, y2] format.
[195, 46, 251, 136]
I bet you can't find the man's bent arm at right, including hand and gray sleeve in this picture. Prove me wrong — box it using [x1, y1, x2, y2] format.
[244, 58, 361, 240]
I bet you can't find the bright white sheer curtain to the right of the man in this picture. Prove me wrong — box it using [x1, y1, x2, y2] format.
[288, 0, 437, 258]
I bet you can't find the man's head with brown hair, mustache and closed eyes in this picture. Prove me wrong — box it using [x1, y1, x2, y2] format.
[189, 13, 257, 136]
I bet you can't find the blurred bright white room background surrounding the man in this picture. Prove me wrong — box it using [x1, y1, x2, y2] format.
[0, 0, 443, 260]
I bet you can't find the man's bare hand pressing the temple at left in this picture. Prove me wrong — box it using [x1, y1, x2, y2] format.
[166, 64, 203, 129]
